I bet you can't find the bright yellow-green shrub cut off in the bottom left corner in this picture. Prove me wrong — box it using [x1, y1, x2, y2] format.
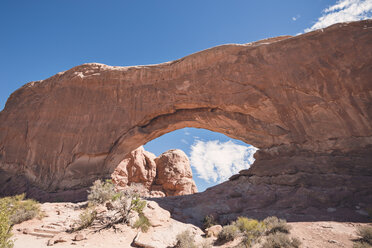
[0, 202, 13, 248]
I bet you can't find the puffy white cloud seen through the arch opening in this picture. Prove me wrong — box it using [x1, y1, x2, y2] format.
[190, 140, 257, 182]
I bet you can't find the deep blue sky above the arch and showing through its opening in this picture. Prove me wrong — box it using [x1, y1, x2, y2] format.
[0, 0, 372, 192]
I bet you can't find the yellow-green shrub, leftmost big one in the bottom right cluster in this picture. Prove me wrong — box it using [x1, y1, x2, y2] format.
[233, 217, 265, 247]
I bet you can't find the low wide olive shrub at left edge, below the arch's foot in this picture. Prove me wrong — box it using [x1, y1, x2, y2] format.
[0, 194, 41, 225]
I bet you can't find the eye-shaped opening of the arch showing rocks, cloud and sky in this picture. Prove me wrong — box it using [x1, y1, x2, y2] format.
[112, 128, 257, 197]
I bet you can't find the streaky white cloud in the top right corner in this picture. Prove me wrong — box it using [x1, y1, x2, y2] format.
[305, 0, 372, 32]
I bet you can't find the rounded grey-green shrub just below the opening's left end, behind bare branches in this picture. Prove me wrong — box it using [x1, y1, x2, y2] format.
[88, 180, 116, 205]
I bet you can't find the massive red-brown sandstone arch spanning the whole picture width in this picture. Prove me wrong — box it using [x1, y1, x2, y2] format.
[0, 20, 372, 209]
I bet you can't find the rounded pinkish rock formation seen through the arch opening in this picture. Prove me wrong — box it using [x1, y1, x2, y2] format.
[111, 146, 198, 197]
